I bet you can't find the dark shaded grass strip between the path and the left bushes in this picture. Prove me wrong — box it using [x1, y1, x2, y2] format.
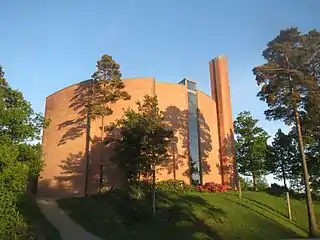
[20, 195, 61, 240]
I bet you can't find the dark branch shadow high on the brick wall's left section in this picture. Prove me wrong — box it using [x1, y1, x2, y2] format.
[58, 80, 90, 146]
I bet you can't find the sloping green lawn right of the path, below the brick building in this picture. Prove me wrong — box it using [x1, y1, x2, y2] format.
[59, 192, 320, 240]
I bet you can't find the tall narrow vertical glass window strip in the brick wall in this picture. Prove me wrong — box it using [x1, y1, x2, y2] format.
[188, 92, 201, 185]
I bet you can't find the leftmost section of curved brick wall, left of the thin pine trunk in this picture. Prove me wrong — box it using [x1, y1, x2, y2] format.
[38, 80, 88, 196]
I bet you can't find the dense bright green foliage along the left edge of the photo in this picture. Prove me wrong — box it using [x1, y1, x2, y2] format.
[0, 65, 48, 240]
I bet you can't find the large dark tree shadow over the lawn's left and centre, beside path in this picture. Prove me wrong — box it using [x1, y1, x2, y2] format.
[59, 191, 224, 240]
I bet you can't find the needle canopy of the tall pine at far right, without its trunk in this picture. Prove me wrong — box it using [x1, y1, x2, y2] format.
[253, 28, 320, 124]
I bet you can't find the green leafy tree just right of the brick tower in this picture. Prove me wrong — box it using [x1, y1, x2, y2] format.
[234, 112, 269, 188]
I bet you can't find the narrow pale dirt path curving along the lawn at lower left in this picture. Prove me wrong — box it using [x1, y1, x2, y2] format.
[37, 198, 102, 240]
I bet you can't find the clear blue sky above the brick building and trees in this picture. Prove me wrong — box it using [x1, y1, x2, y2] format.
[0, 0, 320, 182]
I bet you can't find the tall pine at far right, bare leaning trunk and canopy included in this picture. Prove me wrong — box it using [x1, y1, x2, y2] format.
[253, 28, 319, 237]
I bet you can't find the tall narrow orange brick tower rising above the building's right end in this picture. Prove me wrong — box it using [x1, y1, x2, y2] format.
[209, 56, 237, 186]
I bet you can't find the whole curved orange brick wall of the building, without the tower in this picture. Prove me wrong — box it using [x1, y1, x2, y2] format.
[38, 74, 235, 197]
